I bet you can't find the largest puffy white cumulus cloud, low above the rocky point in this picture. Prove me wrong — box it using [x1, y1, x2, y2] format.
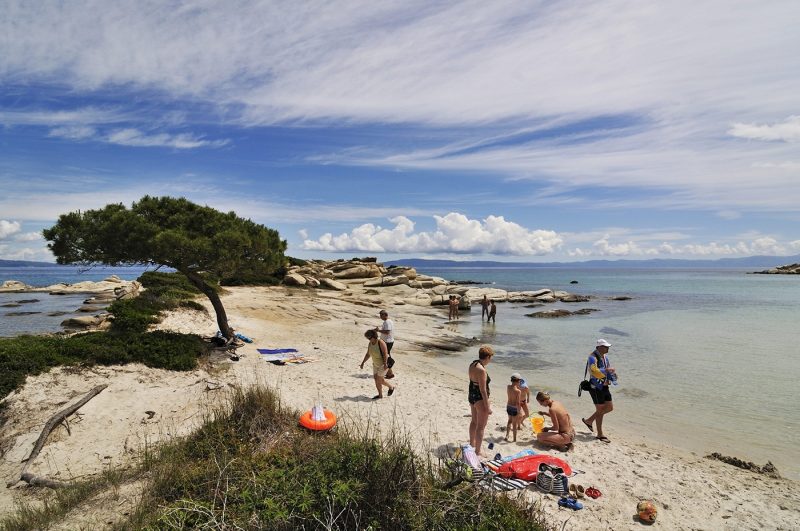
[302, 212, 563, 256]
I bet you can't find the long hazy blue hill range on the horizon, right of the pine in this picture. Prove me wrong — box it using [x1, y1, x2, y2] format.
[385, 255, 800, 269]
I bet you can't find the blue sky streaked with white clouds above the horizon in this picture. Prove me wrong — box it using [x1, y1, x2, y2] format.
[0, 0, 800, 262]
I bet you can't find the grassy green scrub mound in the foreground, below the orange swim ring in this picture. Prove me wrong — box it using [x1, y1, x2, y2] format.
[126, 389, 540, 530]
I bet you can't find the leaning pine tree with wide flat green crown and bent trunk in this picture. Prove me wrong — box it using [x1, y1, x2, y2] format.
[42, 196, 286, 337]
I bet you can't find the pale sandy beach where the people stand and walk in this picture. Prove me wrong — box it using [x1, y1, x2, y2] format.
[0, 286, 800, 529]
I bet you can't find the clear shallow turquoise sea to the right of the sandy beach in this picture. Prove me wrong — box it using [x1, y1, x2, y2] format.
[422, 268, 800, 479]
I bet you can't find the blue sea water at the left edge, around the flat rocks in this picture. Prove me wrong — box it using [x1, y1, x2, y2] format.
[0, 266, 146, 337]
